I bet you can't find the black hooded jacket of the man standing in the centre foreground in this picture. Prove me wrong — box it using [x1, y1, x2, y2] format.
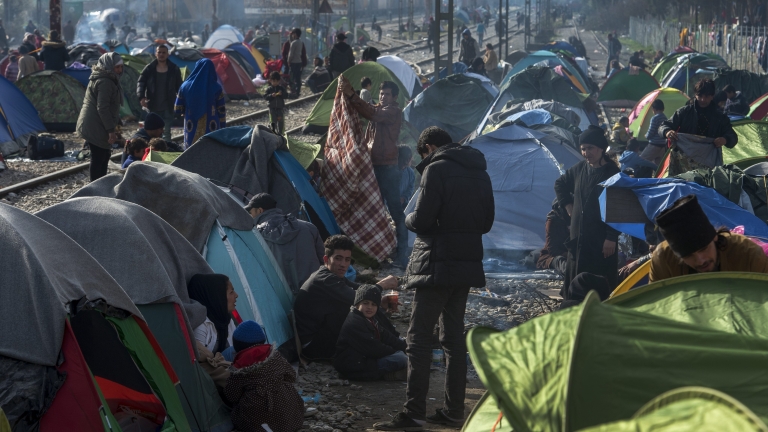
[405, 144, 495, 288]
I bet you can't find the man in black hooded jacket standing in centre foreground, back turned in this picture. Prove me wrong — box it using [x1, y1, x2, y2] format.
[374, 126, 495, 431]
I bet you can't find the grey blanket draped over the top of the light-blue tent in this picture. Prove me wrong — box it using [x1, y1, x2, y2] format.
[72, 161, 253, 252]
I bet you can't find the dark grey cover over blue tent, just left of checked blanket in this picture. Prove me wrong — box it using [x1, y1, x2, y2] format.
[171, 125, 301, 214]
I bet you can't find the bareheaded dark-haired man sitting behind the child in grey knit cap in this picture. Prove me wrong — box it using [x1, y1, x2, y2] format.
[293, 235, 399, 360]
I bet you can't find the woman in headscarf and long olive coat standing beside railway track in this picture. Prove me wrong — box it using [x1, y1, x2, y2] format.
[77, 52, 123, 181]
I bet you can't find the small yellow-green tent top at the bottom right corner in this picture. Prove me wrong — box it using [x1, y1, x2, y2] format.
[581, 387, 768, 432]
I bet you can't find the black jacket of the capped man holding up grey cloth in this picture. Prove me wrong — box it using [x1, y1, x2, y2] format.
[659, 101, 739, 148]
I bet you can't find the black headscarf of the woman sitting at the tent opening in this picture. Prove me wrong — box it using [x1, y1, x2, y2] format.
[187, 274, 232, 354]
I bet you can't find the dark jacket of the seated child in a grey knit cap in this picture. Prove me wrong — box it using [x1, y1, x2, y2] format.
[333, 308, 406, 380]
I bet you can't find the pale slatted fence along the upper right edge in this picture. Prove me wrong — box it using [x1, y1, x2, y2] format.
[629, 17, 768, 74]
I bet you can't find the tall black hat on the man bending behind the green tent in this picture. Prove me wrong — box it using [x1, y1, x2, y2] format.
[656, 195, 717, 257]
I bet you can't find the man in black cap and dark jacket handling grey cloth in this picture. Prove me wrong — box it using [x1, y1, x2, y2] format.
[659, 78, 739, 176]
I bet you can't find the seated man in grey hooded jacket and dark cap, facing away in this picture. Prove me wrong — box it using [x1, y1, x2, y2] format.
[245, 193, 323, 295]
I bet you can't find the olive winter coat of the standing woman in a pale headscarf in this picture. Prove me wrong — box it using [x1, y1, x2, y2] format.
[77, 68, 123, 149]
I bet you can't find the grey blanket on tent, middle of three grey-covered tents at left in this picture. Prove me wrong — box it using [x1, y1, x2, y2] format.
[35, 197, 213, 334]
